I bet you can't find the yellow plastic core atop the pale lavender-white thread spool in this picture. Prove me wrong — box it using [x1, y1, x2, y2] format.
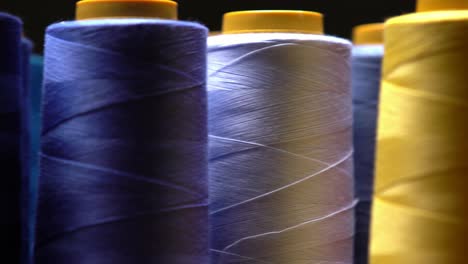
[222, 10, 323, 35]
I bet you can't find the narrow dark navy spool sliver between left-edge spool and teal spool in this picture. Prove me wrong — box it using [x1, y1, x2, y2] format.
[19, 38, 34, 264]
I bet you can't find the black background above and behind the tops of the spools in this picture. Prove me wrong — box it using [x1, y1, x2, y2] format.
[0, 0, 415, 52]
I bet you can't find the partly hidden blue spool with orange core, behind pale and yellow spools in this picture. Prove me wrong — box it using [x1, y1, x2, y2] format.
[351, 24, 384, 264]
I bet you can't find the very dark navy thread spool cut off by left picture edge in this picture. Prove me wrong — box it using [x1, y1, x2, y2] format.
[0, 13, 22, 264]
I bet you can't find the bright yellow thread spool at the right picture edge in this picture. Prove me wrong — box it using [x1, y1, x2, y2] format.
[371, 1, 468, 264]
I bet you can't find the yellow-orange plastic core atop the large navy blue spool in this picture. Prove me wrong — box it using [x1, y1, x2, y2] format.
[76, 0, 177, 20]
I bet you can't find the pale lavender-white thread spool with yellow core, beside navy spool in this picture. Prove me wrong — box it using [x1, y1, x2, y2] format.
[208, 11, 355, 264]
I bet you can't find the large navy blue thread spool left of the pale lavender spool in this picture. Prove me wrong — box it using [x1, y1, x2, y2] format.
[35, 1, 208, 264]
